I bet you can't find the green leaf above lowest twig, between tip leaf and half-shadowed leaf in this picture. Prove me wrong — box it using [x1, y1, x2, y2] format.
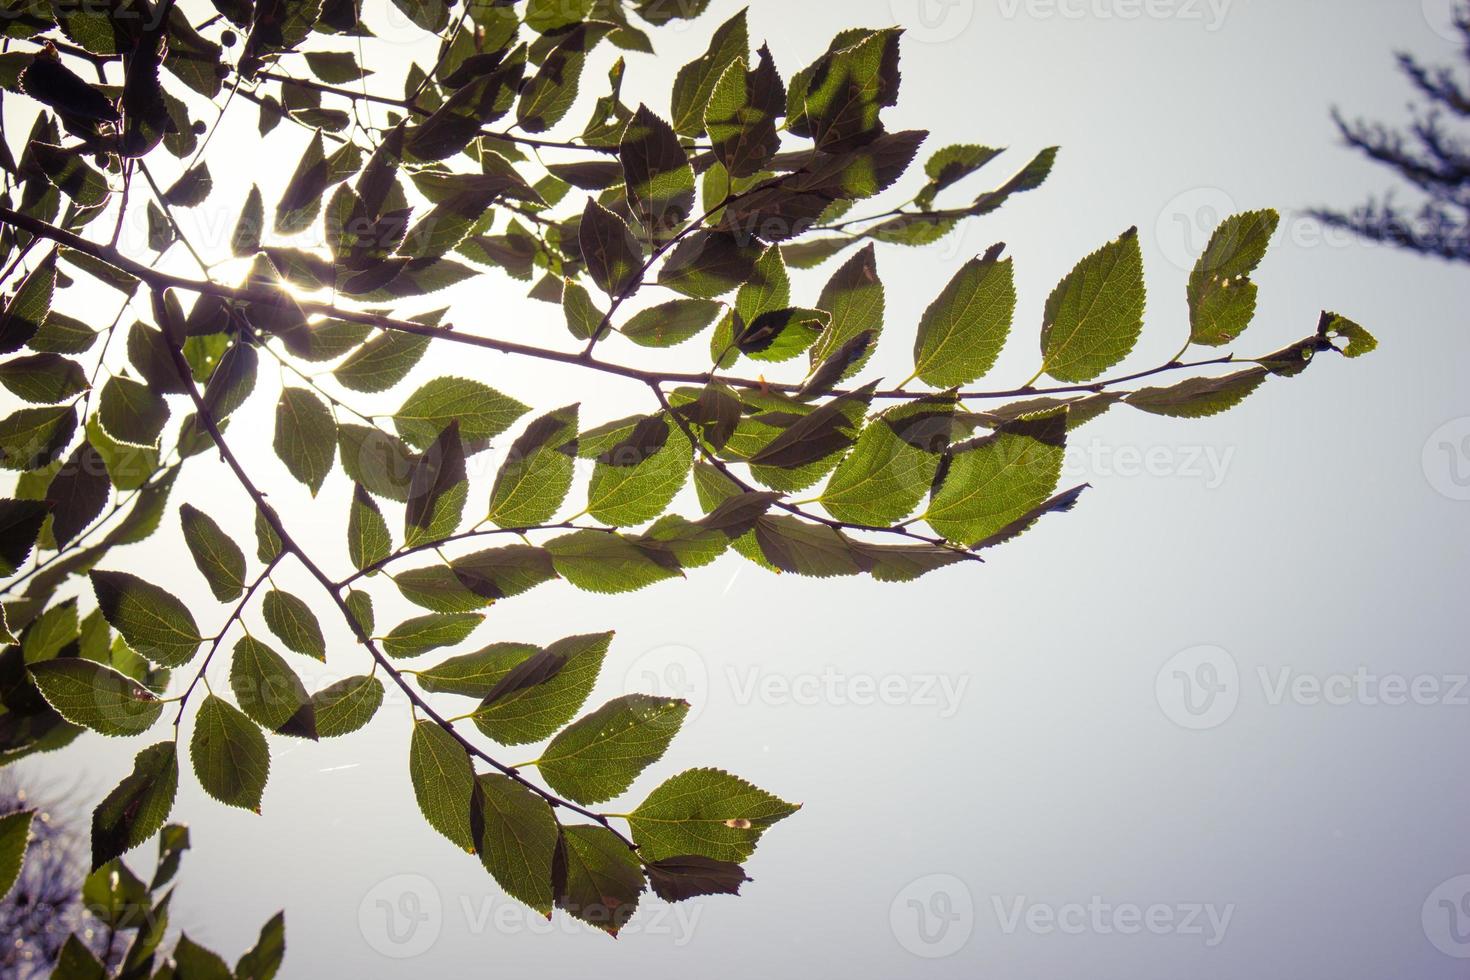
[537, 693, 689, 804]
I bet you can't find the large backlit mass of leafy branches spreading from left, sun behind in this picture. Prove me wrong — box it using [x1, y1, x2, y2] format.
[0, 0, 1374, 952]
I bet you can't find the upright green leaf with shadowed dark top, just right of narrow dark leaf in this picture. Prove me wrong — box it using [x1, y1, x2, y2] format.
[490, 406, 578, 527]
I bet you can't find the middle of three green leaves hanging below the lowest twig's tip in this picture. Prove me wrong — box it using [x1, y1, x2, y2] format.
[475, 776, 560, 917]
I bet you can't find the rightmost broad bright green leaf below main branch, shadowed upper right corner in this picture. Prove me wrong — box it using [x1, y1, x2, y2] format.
[925, 413, 1067, 547]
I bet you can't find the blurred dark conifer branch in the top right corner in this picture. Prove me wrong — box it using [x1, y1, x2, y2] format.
[1313, 4, 1470, 262]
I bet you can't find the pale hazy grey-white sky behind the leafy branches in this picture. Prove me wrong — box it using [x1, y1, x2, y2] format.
[11, 0, 1470, 980]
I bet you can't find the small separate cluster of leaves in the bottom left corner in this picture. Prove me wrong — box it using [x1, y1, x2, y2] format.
[0, 805, 285, 980]
